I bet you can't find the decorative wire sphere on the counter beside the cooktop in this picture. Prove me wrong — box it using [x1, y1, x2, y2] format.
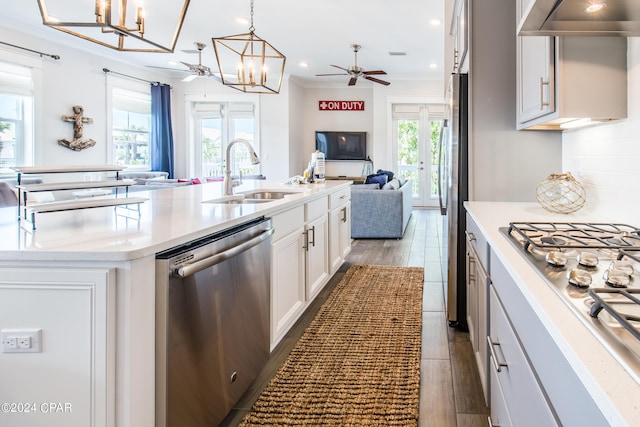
[536, 172, 586, 214]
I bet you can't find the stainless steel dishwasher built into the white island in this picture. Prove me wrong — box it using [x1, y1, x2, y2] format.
[156, 218, 273, 427]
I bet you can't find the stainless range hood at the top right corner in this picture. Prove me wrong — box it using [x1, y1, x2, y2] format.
[518, 0, 640, 37]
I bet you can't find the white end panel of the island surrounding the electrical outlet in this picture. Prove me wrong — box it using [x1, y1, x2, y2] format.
[0, 267, 116, 427]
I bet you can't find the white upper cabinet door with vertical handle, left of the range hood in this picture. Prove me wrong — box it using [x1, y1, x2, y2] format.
[517, 36, 555, 123]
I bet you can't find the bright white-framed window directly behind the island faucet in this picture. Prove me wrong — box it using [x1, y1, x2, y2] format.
[194, 102, 260, 177]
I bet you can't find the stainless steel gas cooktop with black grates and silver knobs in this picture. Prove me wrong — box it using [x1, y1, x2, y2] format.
[500, 222, 640, 383]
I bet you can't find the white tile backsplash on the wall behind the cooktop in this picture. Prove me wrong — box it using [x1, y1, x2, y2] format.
[562, 37, 640, 227]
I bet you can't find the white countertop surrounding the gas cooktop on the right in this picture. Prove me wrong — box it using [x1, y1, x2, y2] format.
[465, 202, 640, 426]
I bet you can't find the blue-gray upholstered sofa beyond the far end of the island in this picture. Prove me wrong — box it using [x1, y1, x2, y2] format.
[351, 180, 413, 239]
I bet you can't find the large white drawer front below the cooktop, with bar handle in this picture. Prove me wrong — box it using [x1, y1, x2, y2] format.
[489, 286, 558, 427]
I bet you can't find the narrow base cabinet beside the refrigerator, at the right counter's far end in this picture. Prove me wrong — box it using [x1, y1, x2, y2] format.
[466, 214, 491, 404]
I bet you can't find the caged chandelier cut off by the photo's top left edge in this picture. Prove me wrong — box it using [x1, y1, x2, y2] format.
[38, 0, 190, 53]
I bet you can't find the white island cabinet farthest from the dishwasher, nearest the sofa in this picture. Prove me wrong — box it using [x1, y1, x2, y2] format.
[329, 188, 351, 274]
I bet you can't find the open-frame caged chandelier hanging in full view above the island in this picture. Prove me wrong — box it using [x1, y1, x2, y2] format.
[212, 0, 286, 94]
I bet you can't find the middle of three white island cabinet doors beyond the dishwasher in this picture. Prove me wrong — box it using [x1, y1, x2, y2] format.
[305, 213, 329, 300]
